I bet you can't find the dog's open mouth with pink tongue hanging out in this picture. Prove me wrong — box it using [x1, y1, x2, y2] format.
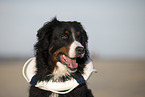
[59, 54, 78, 71]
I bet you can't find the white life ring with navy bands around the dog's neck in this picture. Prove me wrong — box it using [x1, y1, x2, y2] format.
[22, 58, 95, 94]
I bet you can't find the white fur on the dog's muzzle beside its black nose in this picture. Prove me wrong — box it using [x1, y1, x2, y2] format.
[69, 41, 83, 58]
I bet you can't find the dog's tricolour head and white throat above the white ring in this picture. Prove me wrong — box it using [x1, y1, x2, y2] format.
[35, 18, 88, 78]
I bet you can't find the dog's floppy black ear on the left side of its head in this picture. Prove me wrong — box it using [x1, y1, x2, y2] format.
[35, 17, 59, 50]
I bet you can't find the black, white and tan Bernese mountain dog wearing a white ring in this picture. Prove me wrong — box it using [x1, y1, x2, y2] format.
[24, 17, 94, 97]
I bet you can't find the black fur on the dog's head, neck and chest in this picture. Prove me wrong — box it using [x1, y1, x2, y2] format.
[29, 18, 93, 97]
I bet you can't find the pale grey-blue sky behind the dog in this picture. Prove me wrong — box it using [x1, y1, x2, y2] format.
[0, 0, 145, 58]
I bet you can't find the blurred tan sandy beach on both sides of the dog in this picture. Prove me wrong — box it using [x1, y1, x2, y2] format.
[0, 60, 145, 97]
